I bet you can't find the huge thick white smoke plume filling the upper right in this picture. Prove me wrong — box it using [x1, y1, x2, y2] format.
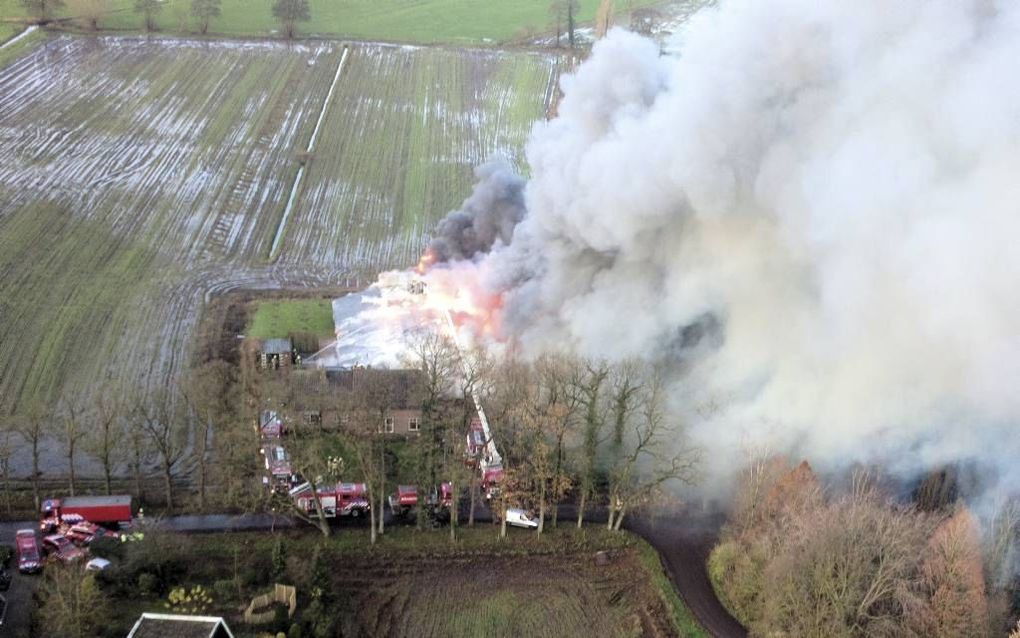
[432, 0, 1020, 487]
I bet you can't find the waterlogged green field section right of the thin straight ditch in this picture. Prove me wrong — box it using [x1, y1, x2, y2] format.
[278, 46, 556, 273]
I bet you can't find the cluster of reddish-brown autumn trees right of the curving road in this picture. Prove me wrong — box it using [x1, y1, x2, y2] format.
[709, 458, 1015, 638]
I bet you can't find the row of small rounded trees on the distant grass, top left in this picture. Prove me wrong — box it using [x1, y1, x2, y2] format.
[20, 0, 311, 38]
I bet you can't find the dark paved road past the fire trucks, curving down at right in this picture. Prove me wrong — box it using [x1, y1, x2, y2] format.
[0, 505, 748, 638]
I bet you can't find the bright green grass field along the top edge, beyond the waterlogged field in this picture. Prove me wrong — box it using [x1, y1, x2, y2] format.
[0, 0, 661, 45]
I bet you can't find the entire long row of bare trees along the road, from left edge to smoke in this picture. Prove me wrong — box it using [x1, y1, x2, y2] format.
[0, 320, 700, 538]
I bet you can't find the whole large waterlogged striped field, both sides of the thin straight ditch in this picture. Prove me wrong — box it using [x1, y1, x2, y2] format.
[0, 34, 555, 411]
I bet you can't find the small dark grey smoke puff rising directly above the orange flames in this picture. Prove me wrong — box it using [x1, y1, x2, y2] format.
[429, 159, 524, 262]
